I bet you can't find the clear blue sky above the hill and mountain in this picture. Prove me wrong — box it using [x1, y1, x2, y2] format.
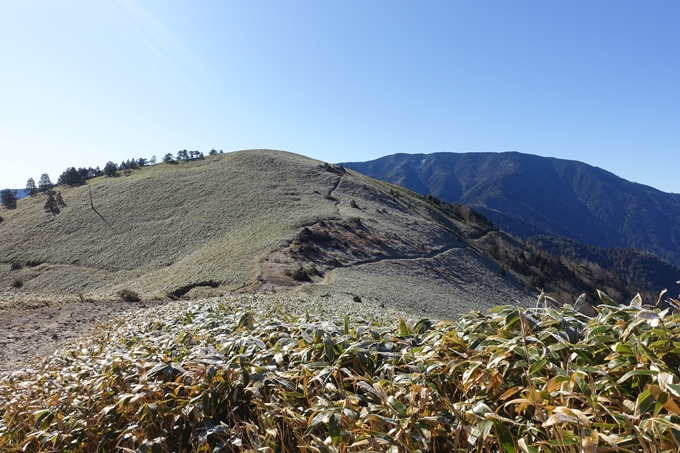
[0, 0, 680, 193]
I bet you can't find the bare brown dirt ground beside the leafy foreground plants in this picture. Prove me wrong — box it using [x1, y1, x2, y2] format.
[0, 302, 169, 375]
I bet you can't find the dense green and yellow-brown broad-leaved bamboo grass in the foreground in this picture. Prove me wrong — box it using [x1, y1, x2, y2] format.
[0, 294, 680, 453]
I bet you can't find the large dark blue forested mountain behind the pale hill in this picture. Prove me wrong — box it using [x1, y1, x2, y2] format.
[342, 152, 680, 266]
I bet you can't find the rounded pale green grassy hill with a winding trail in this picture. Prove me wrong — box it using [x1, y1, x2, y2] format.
[0, 150, 532, 317]
